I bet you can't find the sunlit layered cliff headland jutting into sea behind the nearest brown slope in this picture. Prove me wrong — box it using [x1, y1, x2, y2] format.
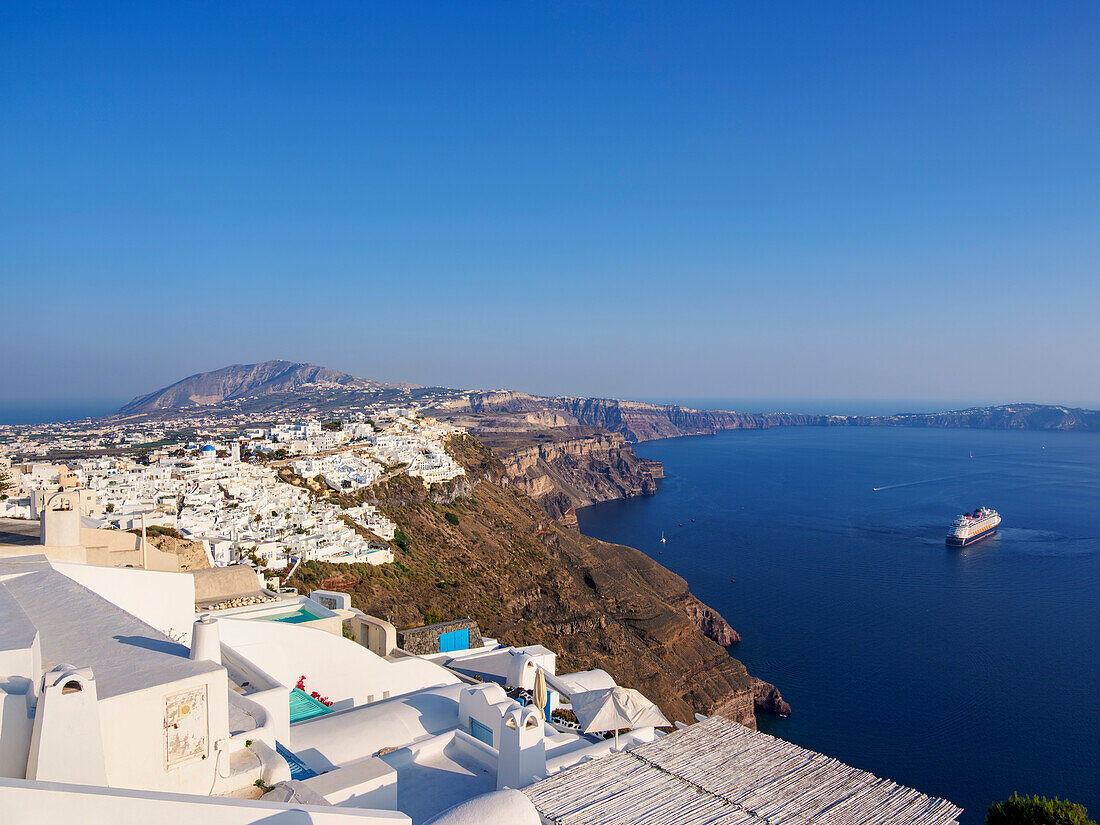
[481, 427, 664, 518]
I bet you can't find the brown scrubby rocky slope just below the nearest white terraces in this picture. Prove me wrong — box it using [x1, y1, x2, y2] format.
[293, 437, 756, 726]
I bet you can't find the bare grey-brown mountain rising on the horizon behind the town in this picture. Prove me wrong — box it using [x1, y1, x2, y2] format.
[119, 361, 415, 415]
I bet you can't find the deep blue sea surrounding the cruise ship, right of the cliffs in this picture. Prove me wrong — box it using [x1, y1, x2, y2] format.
[578, 427, 1100, 825]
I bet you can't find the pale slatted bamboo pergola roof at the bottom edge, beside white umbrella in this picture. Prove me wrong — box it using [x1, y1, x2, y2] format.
[524, 716, 961, 825]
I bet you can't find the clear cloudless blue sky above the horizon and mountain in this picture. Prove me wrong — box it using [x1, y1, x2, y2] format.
[0, 0, 1100, 406]
